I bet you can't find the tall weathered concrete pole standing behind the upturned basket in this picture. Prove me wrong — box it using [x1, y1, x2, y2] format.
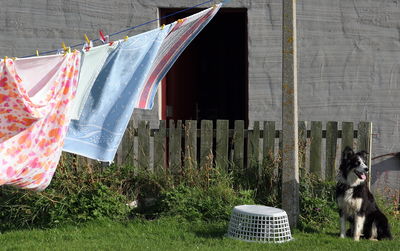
[282, 0, 299, 227]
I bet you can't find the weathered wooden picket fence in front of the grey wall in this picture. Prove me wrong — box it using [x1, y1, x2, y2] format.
[116, 120, 372, 180]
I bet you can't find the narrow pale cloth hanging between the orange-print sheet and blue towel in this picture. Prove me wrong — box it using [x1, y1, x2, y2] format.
[69, 42, 118, 120]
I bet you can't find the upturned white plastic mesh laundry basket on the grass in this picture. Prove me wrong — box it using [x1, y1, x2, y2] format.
[228, 205, 292, 243]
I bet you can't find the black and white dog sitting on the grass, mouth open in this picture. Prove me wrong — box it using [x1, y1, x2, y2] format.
[336, 147, 392, 241]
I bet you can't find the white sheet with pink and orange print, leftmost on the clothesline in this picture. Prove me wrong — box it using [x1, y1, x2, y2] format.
[0, 52, 80, 190]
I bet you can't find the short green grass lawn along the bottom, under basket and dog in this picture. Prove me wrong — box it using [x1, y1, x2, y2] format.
[0, 218, 400, 250]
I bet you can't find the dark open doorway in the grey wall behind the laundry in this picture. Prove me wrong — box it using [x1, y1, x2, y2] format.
[160, 8, 248, 127]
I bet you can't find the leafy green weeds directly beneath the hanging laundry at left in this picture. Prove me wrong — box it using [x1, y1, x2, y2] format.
[0, 157, 129, 230]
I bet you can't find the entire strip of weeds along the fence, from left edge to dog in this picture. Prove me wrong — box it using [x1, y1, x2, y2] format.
[0, 147, 352, 231]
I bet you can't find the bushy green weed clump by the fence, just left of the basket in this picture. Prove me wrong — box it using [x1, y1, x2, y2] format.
[160, 165, 254, 221]
